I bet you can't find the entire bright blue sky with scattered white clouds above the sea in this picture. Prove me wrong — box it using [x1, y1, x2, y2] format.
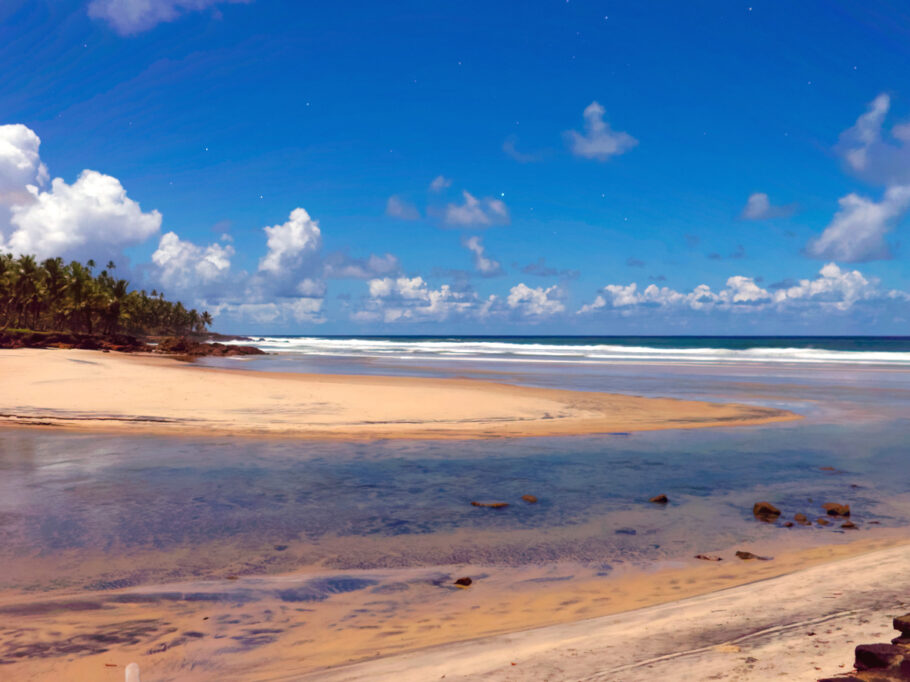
[0, 0, 910, 334]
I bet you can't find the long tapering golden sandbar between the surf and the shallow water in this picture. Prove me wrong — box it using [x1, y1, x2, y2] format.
[0, 349, 800, 439]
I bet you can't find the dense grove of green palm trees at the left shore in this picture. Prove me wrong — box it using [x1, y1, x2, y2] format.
[0, 254, 212, 336]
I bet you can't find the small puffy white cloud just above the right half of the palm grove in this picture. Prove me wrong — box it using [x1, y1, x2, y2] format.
[152, 232, 234, 292]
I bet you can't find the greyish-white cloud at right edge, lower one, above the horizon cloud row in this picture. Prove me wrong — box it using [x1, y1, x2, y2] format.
[807, 185, 910, 263]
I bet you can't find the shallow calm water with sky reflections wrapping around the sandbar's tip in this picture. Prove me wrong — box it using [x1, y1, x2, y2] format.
[0, 358, 910, 679]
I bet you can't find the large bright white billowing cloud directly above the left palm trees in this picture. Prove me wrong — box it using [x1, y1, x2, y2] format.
[6, 170, 161, 258]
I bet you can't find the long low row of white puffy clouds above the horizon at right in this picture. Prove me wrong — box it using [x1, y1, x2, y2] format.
[578, 263, 907, 315]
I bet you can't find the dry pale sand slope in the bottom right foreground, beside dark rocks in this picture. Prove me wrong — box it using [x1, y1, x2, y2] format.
[302, 539, 910, 682]
